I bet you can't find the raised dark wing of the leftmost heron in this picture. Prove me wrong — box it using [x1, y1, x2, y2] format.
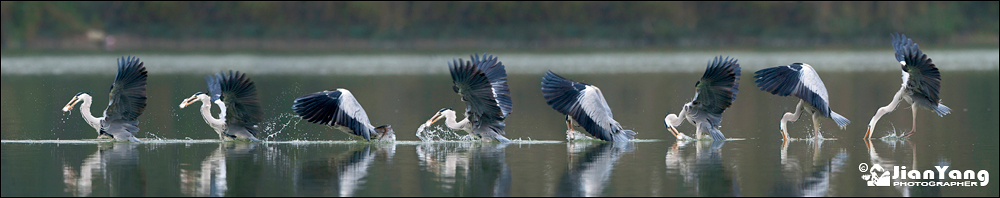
[104, 56, 146, 135]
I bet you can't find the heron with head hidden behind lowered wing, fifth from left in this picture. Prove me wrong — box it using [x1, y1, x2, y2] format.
[542, 71, 636, 142]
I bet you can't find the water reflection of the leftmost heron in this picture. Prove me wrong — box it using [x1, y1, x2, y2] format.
[62, 142, 146, 197]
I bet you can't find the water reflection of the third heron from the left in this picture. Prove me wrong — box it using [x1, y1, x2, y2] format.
[294, 143, 396, 197]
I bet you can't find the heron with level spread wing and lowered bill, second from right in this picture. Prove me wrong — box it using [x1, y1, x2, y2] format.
[753, 63, 851, 140]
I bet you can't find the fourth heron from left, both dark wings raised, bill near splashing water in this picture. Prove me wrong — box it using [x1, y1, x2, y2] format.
[425, 53, 513, 142]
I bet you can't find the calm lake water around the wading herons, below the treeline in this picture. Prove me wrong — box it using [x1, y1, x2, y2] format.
[0, 49, 1000, 197]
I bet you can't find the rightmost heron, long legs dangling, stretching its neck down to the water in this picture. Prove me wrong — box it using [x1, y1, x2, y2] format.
[865, 34, 951, 139]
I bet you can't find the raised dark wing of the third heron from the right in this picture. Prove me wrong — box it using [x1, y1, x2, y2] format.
[692, 56, 740, 126]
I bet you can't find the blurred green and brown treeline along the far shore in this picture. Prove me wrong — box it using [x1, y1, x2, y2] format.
[0, 1, 1000, 49]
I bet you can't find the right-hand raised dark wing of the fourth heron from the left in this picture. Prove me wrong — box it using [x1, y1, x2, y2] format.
[470, 53, 513, 118]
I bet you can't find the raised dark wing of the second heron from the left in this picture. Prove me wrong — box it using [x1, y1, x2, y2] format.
[216, 71, 264, 136]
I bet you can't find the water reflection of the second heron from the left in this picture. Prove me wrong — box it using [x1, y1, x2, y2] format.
[180, 142, 257, 197]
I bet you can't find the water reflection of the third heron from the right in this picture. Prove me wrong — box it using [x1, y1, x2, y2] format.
[665, 141, 740, 197]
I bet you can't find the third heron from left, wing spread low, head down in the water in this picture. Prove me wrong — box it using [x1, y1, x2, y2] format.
[292, 88, 396, 141]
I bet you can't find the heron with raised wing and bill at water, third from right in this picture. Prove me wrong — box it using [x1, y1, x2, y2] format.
[663, 56, 740, 141]
